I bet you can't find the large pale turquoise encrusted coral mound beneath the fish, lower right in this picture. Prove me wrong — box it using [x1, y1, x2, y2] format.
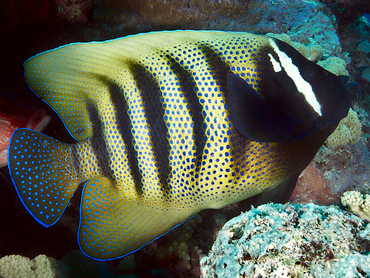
[201, 204, 370, 278]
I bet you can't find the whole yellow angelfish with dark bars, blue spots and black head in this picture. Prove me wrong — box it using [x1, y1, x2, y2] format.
[8, 30, 354, 261]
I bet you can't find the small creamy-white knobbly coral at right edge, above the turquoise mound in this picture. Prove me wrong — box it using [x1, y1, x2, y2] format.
[341, 191, 370, 222]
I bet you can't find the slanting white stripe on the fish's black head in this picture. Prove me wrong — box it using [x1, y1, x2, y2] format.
[269, 39, 322, 116]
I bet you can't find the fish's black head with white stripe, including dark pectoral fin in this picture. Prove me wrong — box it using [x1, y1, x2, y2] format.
[227, 38, 357, 143]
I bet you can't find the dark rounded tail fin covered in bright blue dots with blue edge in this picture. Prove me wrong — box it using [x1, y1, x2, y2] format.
[8, 129, 79, 227]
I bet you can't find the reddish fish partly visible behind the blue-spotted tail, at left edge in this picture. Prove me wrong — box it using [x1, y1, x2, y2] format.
[0, 89, 51, 168]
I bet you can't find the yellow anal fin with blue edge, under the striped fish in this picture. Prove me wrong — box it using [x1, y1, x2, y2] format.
[78, 177, 184, 260]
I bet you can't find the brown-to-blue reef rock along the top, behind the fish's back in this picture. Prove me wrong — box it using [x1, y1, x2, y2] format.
[94, 0, 341, 54]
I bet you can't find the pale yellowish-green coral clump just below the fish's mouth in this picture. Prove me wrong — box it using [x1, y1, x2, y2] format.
[325, 108, 361, 148]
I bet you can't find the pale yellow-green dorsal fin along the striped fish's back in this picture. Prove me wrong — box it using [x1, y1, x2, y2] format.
[24, 31, 243, 141]
